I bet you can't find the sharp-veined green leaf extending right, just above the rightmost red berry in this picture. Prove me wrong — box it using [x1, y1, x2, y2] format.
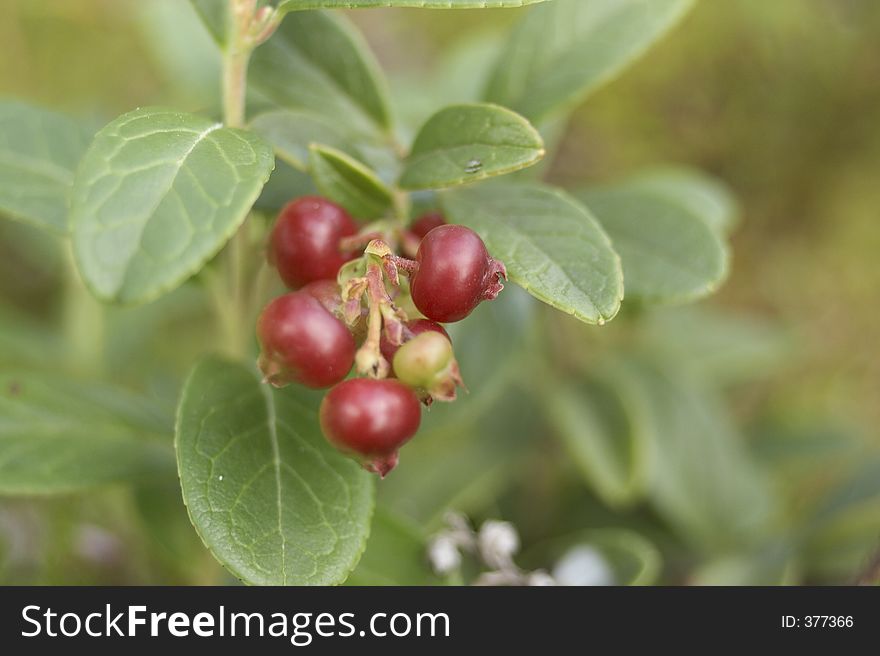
[442, 184, 623, 325]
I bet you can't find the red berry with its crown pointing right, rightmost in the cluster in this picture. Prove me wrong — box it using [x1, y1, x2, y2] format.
[410, 225, 507, 323]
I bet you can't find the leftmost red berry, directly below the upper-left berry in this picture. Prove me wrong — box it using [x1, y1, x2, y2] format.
[257, 291, 355, 389]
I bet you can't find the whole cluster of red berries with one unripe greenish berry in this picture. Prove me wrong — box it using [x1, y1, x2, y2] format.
[257, 196, 506, 476]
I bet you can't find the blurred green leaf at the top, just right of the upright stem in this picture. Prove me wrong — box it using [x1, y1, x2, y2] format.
[249, 11, 391, 132]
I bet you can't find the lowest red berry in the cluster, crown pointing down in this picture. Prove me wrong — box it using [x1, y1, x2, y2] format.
[320, 378, 422, 477]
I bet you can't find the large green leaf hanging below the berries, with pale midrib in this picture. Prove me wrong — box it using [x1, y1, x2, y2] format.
[175, 358, 375, 585]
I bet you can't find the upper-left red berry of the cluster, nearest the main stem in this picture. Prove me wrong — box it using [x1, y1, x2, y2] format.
[269, 196, 358, 289]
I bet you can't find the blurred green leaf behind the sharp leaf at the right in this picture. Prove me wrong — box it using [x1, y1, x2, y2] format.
[577, 177, 730, 302]
